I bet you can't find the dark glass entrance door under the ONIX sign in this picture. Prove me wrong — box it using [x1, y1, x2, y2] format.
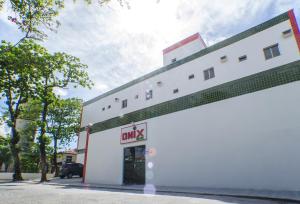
[123, 145, 145, 184]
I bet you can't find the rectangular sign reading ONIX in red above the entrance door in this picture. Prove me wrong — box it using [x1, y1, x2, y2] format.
[120, 123, 147, 144]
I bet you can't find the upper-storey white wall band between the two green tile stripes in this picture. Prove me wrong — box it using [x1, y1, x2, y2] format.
[82, 20, 300, 126]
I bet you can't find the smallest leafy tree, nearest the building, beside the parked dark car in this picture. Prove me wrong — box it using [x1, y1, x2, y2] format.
[47, 98, 82, 176]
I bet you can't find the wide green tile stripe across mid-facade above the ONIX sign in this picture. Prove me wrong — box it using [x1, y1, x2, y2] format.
[81, 60, 300, 133]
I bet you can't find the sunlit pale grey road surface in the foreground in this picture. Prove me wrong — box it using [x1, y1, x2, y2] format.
[0, 182, 296, 204]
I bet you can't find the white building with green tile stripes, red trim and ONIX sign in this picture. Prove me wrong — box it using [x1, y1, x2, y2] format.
[77, 10, 300, 190]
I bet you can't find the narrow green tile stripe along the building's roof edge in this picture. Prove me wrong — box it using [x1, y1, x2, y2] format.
[83, 12, 289, 106]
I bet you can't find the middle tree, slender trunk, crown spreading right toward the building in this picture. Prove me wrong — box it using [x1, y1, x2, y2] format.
[35, 53, 92, 182]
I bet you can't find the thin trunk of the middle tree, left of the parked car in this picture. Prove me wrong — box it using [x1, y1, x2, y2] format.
[39, 102, 49, 182]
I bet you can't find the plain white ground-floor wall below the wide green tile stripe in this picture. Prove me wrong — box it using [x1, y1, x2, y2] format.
[86, 82, 300, 190]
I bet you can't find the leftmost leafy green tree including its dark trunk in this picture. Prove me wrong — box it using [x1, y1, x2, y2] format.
[0, 41, 45, 180]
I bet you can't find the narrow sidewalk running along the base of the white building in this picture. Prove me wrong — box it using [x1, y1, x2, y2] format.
[28, 178, 300, 202]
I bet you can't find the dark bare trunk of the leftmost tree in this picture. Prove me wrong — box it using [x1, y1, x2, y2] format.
[9, 126, 23, 181]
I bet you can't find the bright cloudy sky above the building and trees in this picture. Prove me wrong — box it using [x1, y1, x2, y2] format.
[0, 0, 300, 139]
